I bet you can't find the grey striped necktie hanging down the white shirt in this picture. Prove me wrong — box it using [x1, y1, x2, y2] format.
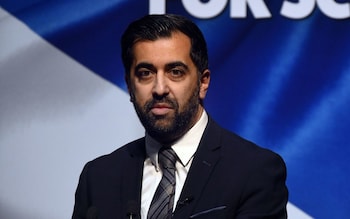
[147, 148, 177, 219]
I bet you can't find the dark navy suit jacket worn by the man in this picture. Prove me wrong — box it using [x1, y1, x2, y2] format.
[73, 118, 288, 219]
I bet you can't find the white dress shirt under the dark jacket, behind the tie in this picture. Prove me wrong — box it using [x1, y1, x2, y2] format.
[141, 111, 208, 219]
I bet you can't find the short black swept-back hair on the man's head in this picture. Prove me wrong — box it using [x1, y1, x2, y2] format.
[121, 14, 208, 78]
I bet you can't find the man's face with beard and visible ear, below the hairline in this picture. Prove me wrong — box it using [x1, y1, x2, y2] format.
[128, 32, 210, 143]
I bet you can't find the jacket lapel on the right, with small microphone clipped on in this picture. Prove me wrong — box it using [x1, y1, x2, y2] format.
[174, 118, 220, 218]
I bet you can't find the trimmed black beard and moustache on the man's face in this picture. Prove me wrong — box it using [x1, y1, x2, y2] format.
[133, 88, 200, 143]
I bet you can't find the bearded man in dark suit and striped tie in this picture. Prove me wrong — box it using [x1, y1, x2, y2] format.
[73, 15, 288, 219]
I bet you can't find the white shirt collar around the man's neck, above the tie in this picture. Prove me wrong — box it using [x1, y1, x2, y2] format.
[146, 110, 208, 171]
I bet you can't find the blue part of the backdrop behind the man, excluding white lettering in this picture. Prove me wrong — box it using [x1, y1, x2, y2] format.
[0, 0, 350, 219]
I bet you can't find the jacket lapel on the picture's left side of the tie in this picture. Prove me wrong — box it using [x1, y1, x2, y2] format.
[121, 138, 146, 218]
